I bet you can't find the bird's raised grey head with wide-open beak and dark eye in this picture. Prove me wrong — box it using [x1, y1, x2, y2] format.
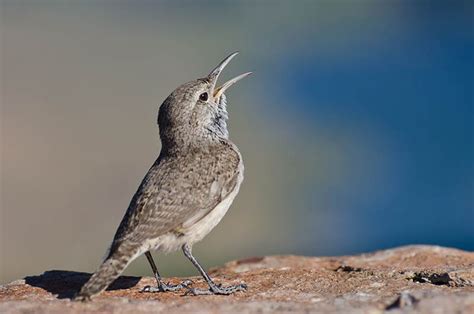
[158, 52, 251, 152]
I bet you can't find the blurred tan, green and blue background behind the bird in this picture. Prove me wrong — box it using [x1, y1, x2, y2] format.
[0, 0, 474, 282]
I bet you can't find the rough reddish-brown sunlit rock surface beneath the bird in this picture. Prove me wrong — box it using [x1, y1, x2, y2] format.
[0, 246, 474, 313]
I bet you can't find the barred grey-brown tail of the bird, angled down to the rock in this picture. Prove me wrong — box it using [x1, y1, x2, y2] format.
[74, 244, 140, 301]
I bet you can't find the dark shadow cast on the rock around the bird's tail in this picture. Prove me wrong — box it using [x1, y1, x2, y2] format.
[25, 270, 140, 299]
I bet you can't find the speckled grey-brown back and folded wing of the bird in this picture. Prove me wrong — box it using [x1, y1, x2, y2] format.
[110, 145, 241, 252]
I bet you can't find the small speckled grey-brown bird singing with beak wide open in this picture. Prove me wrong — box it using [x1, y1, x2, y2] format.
[74, 52, 252, 301]
